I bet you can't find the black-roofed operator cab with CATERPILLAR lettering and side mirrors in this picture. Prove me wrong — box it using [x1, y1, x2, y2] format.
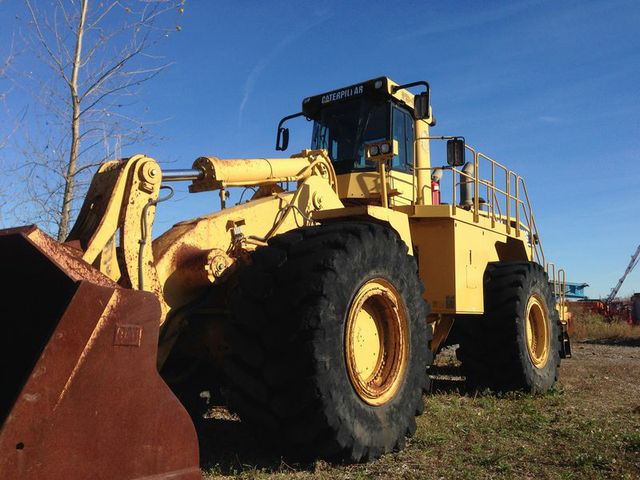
[276, 77, 435, 206]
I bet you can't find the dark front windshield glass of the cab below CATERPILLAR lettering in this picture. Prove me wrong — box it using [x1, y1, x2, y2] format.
[311, 98, 390, 173]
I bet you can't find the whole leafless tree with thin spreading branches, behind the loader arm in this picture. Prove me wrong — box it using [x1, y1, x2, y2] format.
[16, 0, 184, 241]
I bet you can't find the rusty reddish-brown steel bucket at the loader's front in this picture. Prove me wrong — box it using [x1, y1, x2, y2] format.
[0, 227, 200, 480]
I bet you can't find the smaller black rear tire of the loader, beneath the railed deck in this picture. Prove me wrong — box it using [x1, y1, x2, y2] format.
[458, 262, 562, 393]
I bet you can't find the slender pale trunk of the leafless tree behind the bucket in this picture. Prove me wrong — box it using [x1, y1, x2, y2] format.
[58, 0, 88, 242]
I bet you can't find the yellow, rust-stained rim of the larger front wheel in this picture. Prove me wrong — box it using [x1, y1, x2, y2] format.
[345, 278, 409, 405]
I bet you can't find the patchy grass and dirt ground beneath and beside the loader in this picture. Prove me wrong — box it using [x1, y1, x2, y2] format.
[202, 318, 640, 480]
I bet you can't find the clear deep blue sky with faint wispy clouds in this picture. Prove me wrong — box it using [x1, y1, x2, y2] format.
[0, 0, 640, 297]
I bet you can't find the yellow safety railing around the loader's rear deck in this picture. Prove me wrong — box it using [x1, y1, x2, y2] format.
[413, 137, 546, 265]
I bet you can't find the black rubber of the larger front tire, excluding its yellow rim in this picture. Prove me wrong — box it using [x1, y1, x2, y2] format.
[226, 222, 432, 462]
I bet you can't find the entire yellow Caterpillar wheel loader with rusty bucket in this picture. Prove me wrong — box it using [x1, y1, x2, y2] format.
[0, 77, 570, 479]
